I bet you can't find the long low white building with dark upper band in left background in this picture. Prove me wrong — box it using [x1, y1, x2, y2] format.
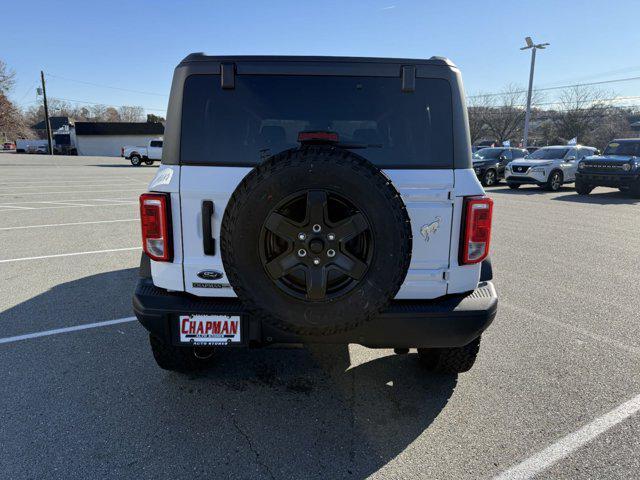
[75, 122, 164, 157]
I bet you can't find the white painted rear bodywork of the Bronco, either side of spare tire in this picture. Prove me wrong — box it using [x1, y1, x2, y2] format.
[150, 166, 484, 299]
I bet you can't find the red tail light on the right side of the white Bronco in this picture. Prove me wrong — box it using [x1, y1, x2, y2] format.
[460, 197, 493, 265]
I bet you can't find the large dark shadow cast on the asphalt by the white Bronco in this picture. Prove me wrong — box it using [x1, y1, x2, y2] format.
[0, 269, 457, 479]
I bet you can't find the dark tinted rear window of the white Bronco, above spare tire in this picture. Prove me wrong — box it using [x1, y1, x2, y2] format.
[180, 75, 453, 168]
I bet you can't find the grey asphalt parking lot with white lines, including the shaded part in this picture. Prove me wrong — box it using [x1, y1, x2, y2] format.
[0, 154, 640, 479]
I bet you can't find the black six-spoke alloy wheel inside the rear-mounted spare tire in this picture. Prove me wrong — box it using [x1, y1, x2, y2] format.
[260, 190, 373, 301]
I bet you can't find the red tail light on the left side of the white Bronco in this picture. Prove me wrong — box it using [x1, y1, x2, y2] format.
[140, 193, 173, 262]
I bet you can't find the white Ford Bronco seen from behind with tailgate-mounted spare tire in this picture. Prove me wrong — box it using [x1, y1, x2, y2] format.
[133, 54, 498, 374]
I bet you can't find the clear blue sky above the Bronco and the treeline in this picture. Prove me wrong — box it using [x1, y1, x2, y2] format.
[5, 0, 640, 114]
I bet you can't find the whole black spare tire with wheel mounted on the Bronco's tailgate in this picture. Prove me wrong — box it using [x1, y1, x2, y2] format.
[220, 146, 412, 335]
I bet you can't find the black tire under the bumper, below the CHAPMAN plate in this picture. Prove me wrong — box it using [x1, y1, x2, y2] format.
[149, 335, 215, 373]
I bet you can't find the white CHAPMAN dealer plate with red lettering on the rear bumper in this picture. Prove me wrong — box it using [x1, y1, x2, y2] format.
[178, 315, 242, 345]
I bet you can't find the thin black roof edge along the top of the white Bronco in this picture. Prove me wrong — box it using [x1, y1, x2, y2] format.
[180, 52, 456, 68]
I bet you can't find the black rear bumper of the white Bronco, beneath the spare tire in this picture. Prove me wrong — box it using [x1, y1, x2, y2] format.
[133, 278, 498, 348]
